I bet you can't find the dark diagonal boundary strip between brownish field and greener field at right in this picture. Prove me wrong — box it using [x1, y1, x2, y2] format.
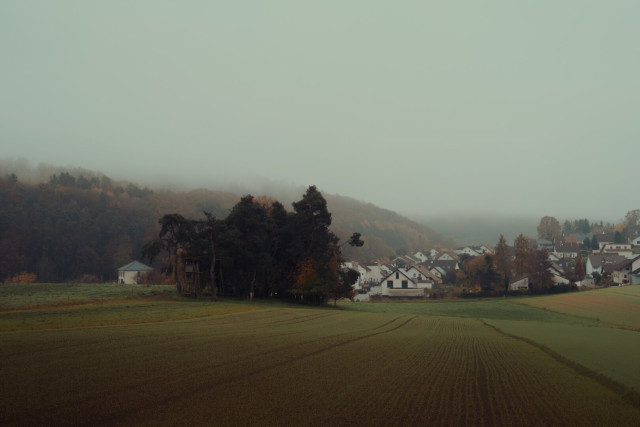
[478, 319, 640, 409]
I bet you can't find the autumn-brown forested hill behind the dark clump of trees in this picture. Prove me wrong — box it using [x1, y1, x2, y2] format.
[0, 172, 449, 282]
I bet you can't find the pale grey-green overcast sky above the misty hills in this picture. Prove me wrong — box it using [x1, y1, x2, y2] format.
[0, 0, 640, 220]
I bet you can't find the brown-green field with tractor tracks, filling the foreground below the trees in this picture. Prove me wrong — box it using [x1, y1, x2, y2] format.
[0, 285, 640, 425]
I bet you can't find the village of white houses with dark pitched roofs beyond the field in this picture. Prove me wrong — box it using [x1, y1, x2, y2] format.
[343, 231, 640, 301]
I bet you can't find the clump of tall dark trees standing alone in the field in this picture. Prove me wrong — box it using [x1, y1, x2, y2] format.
[143, 186, 363, 304]
